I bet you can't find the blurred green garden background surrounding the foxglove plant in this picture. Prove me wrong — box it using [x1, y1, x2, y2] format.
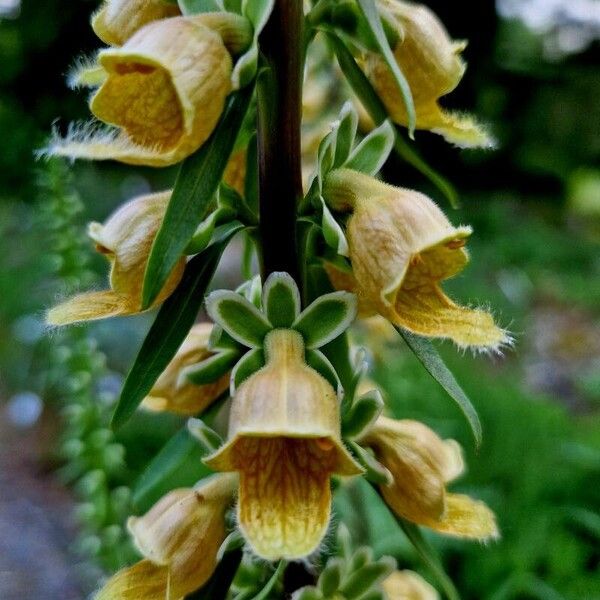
[0, 0, 600, 600]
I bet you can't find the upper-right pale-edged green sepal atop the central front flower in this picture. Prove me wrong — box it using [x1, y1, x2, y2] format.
[292, 292, 356, 348]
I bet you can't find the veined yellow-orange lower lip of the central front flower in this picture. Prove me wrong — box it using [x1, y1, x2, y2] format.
[235, 438, 337, 560]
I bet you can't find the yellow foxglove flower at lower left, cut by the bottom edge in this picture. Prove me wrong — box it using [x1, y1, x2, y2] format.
[95, 474, 237, 600]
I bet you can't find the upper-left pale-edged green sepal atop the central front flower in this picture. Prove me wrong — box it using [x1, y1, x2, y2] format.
[206, 290, 272, 348]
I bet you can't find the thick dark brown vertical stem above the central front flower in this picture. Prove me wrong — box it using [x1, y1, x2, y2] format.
[257, 0, 304, 283]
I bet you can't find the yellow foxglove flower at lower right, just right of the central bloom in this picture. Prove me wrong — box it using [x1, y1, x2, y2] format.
[361, 417, 499, 540]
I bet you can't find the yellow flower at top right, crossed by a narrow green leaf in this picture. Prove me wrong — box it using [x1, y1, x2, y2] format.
[364, 0, 493, 147]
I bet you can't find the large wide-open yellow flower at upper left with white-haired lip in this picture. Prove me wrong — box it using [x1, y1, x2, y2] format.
[47, 17, 232, 166]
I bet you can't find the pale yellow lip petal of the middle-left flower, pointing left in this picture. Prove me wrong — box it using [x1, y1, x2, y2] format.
[46, 290, 137, 326]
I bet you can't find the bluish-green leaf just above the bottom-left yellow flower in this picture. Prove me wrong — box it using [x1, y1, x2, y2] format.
[133, 428, 210, 512]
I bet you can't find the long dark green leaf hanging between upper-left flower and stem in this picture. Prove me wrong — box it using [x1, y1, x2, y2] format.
[142, 88, 253, 308]
